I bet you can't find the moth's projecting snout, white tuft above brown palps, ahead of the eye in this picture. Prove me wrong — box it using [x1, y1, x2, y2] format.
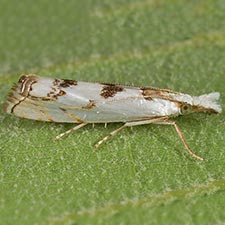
[191, 92, 222, 114]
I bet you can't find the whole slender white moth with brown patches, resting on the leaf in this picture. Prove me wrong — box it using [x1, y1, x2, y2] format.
[4, 74, 222, 160]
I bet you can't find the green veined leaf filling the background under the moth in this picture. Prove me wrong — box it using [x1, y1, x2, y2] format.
[0, 0, 225, 225]
